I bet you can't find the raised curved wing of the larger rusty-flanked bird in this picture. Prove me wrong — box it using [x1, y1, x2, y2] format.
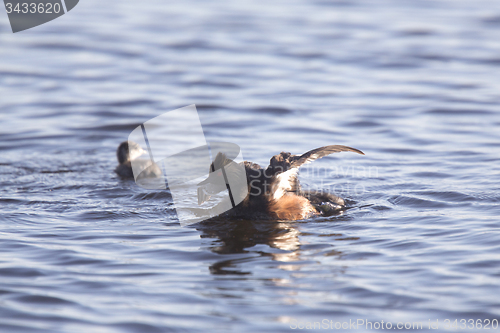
[266, 145, 364, 200]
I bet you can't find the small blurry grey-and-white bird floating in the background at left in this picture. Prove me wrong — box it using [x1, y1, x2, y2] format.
[115, 141, 162, 179]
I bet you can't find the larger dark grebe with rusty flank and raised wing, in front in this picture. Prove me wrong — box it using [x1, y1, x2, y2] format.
[198, 145, 364, 220]
